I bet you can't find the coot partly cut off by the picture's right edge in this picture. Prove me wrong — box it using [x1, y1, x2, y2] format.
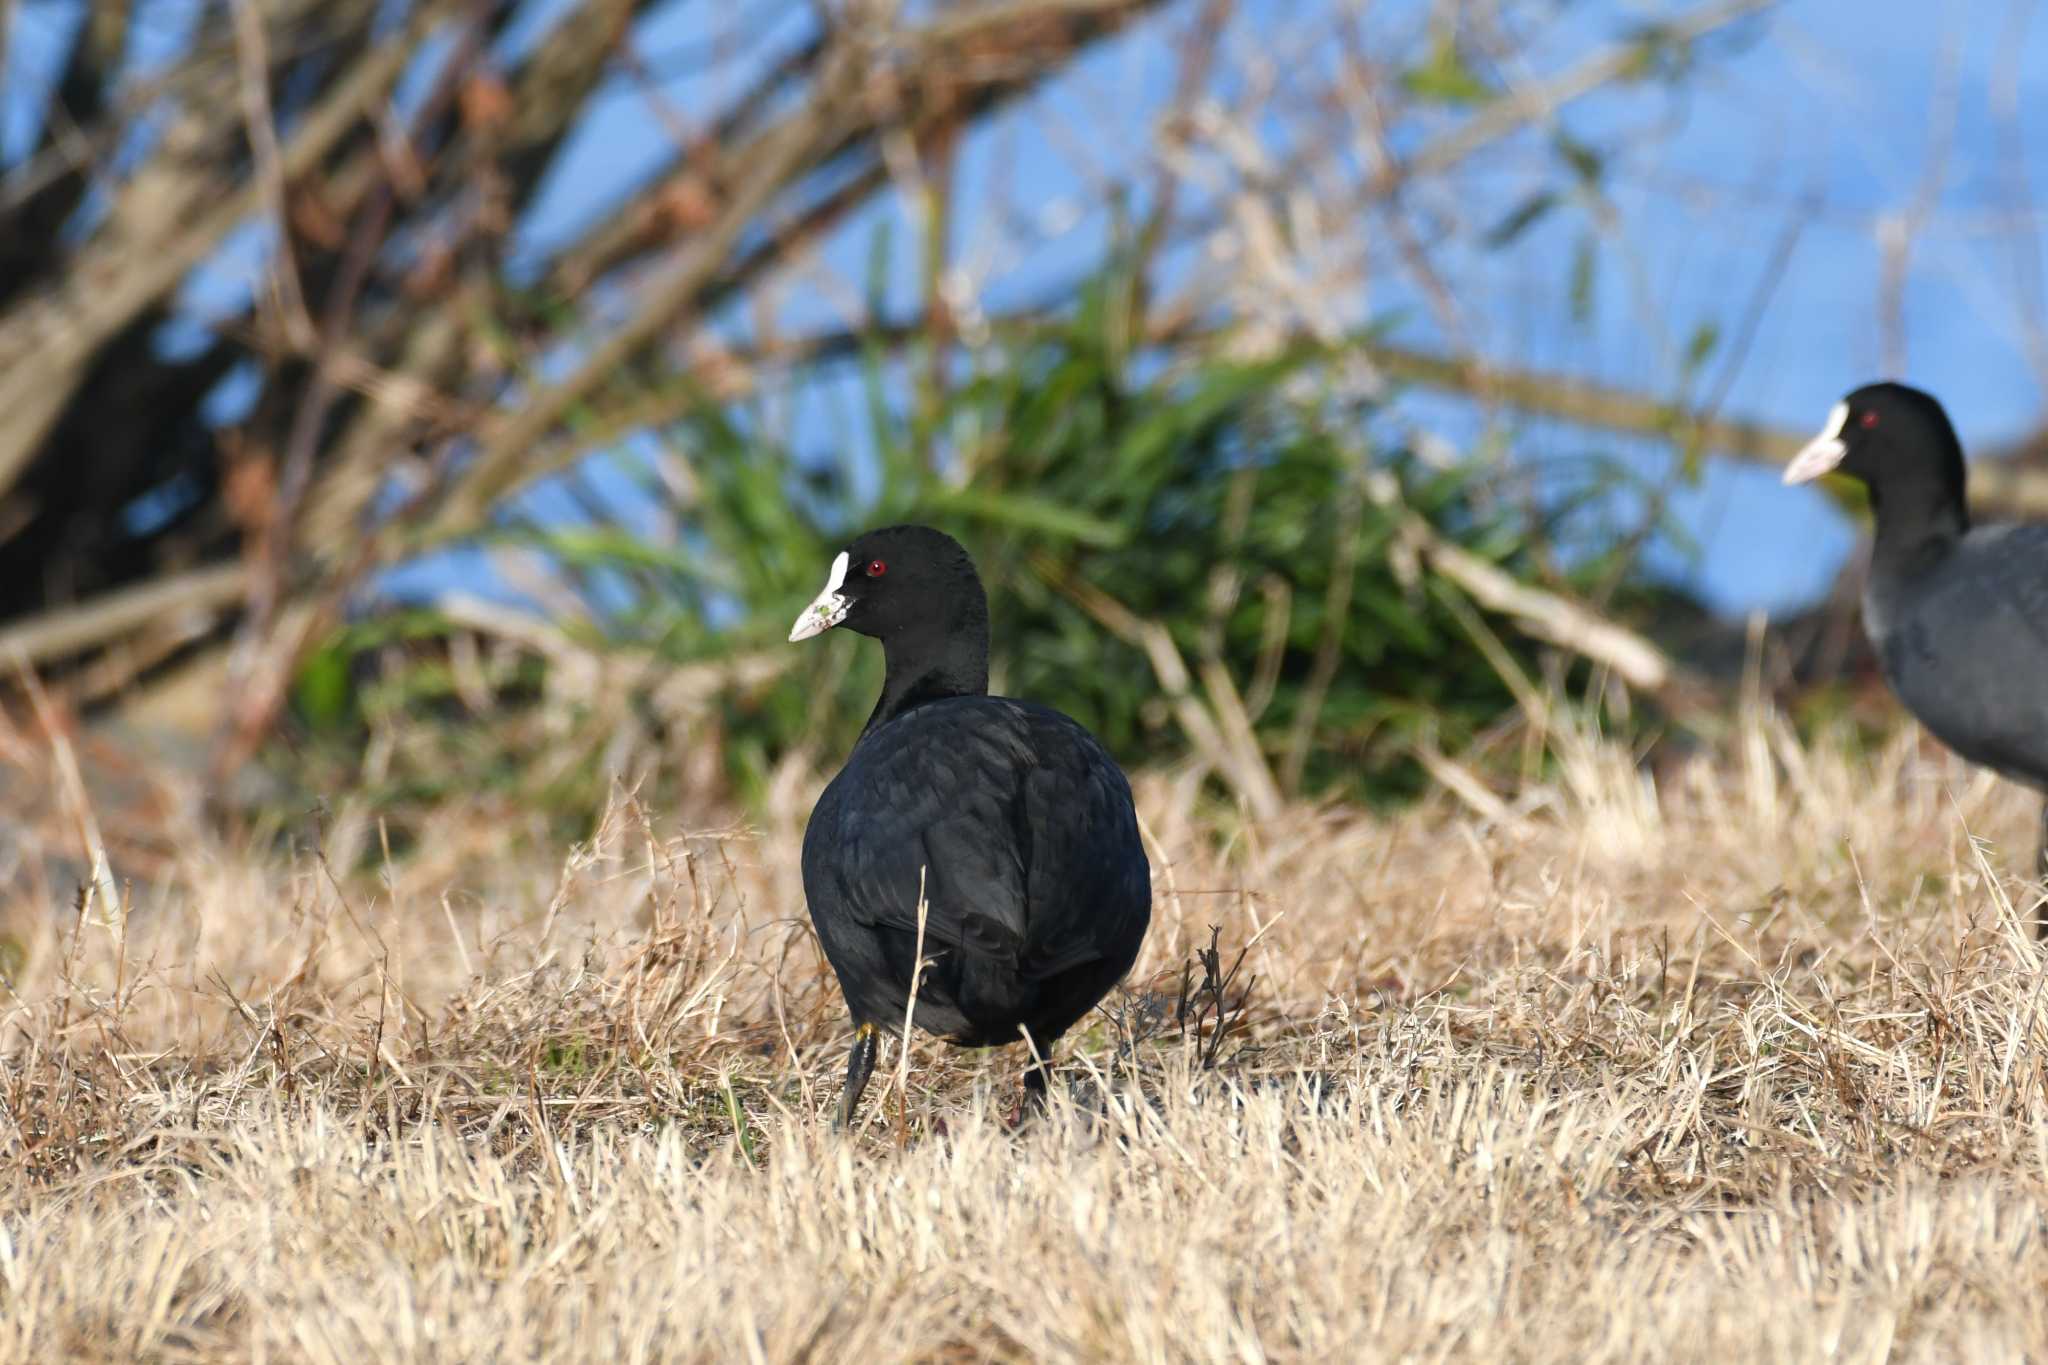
[1786, 385, 2048, 937]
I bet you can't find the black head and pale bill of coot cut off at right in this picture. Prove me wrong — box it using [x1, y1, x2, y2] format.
[1786, 383, 1964, 514]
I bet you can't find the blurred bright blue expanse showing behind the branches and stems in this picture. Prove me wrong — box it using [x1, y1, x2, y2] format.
[0, 0, 2048, 612]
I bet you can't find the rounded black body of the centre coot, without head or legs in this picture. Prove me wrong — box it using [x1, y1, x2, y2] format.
[803, 696, 1151, 1050]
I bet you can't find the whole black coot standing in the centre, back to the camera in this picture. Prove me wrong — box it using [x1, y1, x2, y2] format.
[788, 526, 1151, 1126]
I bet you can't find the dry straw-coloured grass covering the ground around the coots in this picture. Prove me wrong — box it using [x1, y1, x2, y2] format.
[0, 718, 2048, 1365]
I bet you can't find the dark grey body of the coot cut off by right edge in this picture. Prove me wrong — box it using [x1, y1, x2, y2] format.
[1880, 524, 2048, 788]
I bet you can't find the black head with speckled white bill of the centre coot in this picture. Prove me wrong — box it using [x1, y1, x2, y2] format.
[788, 526, 989, 643]
